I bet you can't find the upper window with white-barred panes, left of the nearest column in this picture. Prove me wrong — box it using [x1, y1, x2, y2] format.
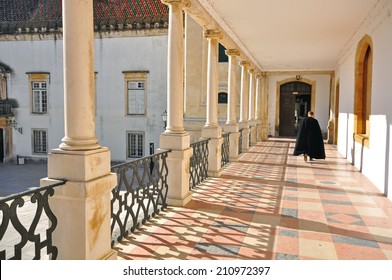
[28, 73, 49, 114]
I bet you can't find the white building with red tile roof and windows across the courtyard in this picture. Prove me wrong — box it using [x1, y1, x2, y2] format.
[0, 0, 167, 161]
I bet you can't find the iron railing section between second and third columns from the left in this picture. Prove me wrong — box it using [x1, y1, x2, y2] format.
[189, 138, 210, 190]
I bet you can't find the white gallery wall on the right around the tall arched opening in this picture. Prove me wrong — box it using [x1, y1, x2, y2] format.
[336, 0, 392, 196]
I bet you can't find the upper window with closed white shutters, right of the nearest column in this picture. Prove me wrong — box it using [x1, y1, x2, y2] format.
[124, 71, 148, 115]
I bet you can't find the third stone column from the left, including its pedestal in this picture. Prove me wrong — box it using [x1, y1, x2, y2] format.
[201, 30, 223, 177]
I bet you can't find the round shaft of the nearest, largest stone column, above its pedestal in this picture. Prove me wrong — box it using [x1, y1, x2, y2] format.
[60, 0, 100, 150]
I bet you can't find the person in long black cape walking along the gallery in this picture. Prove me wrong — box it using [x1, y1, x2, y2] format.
[293, 111, 325, 161]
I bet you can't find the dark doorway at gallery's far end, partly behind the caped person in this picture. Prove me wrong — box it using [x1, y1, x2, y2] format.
[279, 82, 312, 137]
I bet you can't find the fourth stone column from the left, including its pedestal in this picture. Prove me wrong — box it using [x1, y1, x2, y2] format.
[223, 49, 240, 161]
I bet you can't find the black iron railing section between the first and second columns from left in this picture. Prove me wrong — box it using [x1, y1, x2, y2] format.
[111, 151, 170, 245]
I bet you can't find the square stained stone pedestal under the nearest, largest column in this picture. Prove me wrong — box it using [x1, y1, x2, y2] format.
[41, 148, 117, 260]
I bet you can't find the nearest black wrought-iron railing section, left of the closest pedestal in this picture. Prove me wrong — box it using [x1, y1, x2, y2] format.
[0, 181, 65, 260]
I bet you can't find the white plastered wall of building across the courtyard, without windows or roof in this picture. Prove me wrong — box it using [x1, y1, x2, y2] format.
[0, 34, 167, 161]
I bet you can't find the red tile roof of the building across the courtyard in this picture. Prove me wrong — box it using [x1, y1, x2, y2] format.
[0, 0, 168, 33]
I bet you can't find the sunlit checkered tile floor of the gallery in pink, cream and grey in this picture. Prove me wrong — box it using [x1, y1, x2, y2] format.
[115, 140, 392, 260]
